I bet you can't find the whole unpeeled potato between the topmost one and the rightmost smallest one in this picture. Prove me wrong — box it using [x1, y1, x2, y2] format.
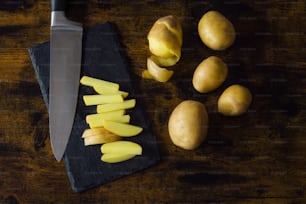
[192, 56, 228, 93]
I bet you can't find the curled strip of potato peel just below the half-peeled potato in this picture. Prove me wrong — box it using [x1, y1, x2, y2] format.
[147, 58, 173, 82]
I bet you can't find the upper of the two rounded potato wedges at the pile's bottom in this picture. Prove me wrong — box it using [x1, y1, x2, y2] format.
[101, 141, 142, 155]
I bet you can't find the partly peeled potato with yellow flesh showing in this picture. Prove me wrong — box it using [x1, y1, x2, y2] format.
[148, 15, 183, 66]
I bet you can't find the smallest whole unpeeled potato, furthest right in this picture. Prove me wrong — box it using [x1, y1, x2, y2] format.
[218, 84, 252, 116]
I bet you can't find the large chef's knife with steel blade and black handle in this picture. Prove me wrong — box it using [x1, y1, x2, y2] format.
[49, 0, 83, 161]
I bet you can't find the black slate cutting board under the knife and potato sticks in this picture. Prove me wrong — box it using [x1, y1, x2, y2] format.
[29, 22, 160, 192]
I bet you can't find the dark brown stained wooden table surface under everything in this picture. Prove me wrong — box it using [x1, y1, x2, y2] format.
[0, 0, 306, 204]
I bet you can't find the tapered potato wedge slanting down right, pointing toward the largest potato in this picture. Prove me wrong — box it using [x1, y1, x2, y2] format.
[103, 120, 143, 137]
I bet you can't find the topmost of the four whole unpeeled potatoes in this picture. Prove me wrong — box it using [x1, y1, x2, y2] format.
[198, 11, 236, 50]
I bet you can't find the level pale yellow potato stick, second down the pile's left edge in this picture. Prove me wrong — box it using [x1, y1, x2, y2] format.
[83, 94, 123, 106]
